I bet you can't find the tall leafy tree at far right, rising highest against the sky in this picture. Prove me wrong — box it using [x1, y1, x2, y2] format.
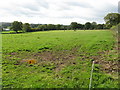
[104, 13, 120, 26]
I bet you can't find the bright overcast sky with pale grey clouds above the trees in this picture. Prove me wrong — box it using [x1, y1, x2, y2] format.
[0, 0, 119, 25]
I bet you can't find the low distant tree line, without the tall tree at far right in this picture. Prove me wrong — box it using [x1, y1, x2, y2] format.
[7, 21, 109, 33]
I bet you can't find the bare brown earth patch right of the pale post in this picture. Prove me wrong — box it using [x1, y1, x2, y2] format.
[92, 48, 119, 74]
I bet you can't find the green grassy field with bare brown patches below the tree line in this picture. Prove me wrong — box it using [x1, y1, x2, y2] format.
[2, 30, 118, 88]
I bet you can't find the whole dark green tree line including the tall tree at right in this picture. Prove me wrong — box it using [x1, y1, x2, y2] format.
[1, 13, 120, 33]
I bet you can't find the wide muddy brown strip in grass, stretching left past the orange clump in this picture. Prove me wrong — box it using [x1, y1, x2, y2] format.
[6, 49, 78, 72]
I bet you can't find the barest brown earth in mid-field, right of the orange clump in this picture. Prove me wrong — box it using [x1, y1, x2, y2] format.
[33, 51, 76, 71]
